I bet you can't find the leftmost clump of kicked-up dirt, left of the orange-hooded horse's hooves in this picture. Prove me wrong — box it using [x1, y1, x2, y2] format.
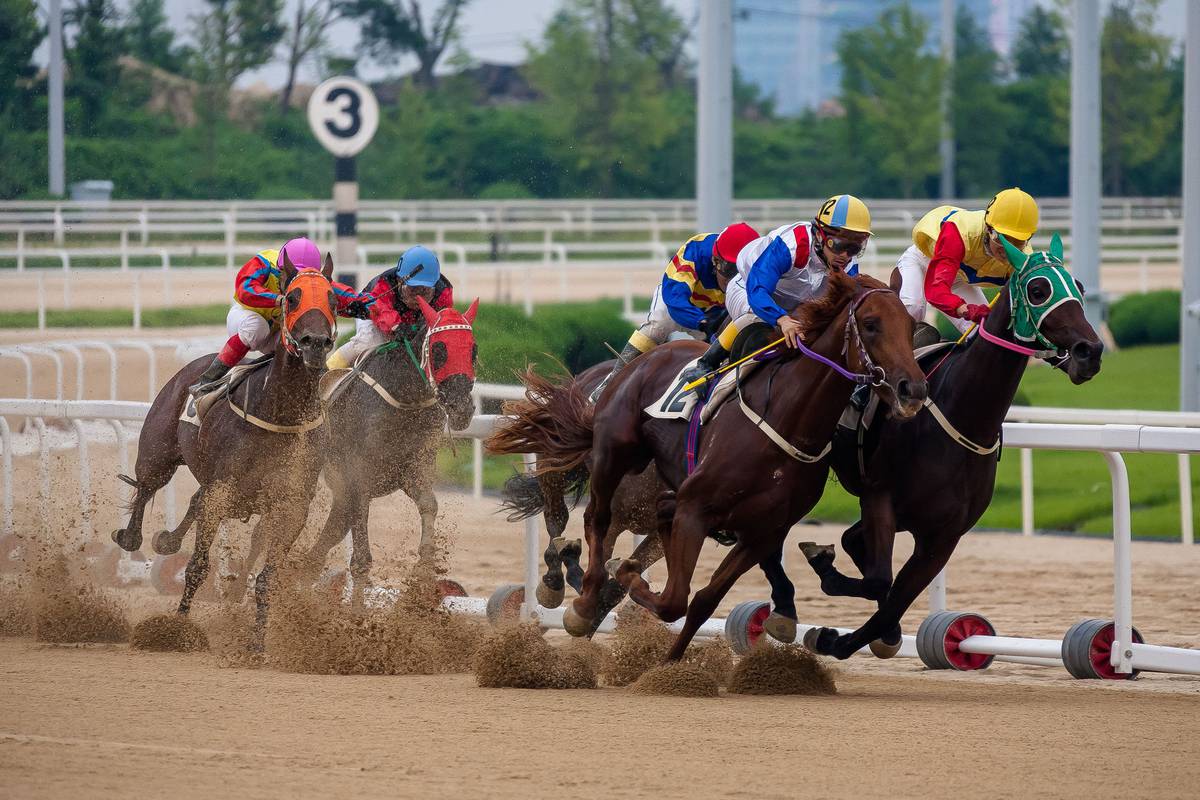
[31, 554, 130, 644]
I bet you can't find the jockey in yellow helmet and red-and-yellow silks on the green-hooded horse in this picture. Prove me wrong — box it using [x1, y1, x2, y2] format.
[896, 188, 1038, 341]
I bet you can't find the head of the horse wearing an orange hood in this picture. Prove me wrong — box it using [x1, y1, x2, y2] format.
[280, 249, 337, 369]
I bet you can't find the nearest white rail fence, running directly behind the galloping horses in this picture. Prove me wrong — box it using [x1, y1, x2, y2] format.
[0, 399, 1200, 675]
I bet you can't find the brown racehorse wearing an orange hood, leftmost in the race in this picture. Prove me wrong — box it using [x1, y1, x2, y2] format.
[113, 252, 336, 632]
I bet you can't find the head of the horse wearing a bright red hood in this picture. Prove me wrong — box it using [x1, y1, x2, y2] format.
[418, 297, 479, 431]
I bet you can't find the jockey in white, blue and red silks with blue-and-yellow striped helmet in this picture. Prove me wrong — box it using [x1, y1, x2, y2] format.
[680, 194, 871, 391]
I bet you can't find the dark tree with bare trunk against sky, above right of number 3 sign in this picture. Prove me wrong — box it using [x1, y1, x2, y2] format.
[341, 0, 469, 89]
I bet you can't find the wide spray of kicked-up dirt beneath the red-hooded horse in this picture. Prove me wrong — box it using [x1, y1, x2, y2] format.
[266, 569, 482, 675]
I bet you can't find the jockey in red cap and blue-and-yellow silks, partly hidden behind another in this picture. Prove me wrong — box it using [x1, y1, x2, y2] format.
[592, 222, 758, 403]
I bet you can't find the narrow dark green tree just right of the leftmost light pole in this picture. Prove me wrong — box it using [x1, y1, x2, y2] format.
[64, 0, 125, 136]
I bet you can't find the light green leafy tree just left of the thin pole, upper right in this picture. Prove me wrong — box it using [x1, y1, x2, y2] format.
[838, 5, 944, 198]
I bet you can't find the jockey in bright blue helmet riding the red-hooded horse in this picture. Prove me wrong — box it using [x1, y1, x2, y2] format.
[325, 245, 454, 369]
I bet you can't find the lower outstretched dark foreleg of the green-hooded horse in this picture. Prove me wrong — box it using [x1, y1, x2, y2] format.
[804, 534, 961, 658]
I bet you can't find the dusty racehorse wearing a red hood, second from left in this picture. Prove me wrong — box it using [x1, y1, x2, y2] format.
[307, 297, 479, 584]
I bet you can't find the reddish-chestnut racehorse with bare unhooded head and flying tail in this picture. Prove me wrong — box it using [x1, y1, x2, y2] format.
[492, 272, 925, 661]
